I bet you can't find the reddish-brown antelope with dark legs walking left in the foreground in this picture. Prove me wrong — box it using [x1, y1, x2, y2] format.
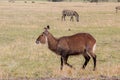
[36, 25, 96, 70]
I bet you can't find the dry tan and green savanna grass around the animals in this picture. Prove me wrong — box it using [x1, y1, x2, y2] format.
[0, 1, 120, 80]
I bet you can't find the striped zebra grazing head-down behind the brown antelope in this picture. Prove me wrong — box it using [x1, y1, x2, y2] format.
[62, 10, 79, 22]
